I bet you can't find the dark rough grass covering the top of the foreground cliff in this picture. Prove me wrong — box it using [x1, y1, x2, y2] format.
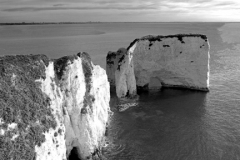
[0, 55, 56, 160]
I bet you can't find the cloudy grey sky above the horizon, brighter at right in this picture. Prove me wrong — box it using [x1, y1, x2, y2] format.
[0, 0, 240, 23]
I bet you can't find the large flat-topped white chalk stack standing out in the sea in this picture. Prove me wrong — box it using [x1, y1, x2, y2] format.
[106, 34, 210, 97]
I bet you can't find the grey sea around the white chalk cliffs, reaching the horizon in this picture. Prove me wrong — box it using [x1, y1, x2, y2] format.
[0, 22, 240, 160]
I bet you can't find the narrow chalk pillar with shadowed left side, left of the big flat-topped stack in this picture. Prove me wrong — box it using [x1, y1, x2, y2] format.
[106, 48, 136, 97]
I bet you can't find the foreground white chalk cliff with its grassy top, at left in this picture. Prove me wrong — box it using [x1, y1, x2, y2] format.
[0, 53, 110, 160]
